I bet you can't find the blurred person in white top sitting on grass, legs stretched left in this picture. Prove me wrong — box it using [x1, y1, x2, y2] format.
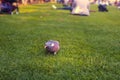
[52, 0, 90, 16]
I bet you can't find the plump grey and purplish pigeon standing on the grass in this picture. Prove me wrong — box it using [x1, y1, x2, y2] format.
[45, 40, 60, 54]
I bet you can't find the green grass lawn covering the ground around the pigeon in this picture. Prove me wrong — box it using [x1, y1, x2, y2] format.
[0, 4, 120, 80]
